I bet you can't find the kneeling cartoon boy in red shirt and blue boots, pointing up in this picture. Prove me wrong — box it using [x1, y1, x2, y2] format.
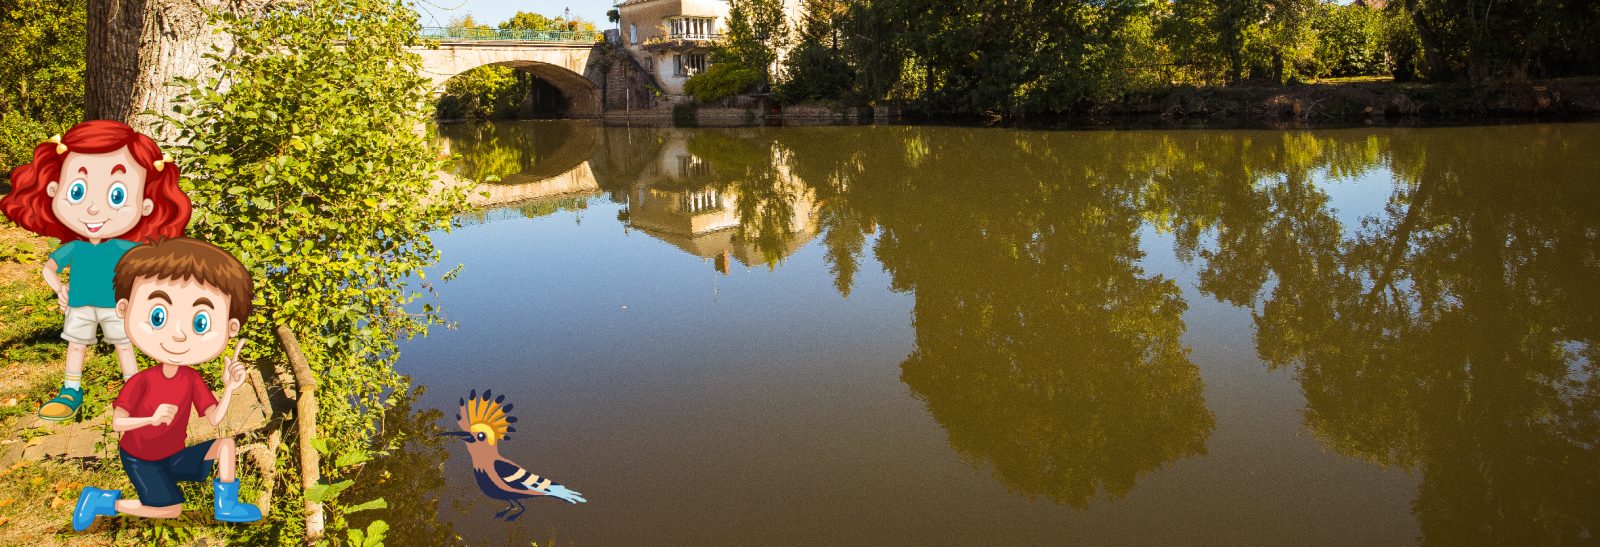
[72, 237, 261, 531]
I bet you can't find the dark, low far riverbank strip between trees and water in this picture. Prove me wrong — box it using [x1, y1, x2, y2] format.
[588, 77, 1600, 126]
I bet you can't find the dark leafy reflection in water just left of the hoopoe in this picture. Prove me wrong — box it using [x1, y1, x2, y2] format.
[339, 387, 456, 545]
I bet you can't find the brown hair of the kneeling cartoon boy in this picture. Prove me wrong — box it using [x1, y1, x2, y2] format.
[112, 237, 253, 325]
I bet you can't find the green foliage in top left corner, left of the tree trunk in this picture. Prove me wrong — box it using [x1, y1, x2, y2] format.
[0, 0, 86, 173]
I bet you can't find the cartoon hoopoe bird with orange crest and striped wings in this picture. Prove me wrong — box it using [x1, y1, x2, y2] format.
[438, 390, 587, 521]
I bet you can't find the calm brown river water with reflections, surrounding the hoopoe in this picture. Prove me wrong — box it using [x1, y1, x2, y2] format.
[377, 122, 1600, 545]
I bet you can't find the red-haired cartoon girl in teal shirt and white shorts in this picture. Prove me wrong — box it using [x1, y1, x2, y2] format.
[0, 120, 189, 421]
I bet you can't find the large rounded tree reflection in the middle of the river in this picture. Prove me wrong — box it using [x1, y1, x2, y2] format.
[786, 130, 1213, 507]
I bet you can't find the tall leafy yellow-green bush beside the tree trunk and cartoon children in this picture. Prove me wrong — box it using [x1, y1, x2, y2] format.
[166, 0, 467, 541]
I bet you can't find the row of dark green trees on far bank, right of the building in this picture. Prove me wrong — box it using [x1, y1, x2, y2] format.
[691, 0, 1600, 115]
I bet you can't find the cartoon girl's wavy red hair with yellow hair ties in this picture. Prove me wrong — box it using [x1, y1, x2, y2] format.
[0, 120, 189, 243]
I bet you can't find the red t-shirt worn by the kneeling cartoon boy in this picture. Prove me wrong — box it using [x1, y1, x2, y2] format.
[112, 365, 216, 461]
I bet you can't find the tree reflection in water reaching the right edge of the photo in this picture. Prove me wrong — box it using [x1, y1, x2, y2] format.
[1177, 126, 1600, 545]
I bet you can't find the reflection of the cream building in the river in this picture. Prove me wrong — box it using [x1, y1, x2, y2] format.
[611, 136, 818, 274]
